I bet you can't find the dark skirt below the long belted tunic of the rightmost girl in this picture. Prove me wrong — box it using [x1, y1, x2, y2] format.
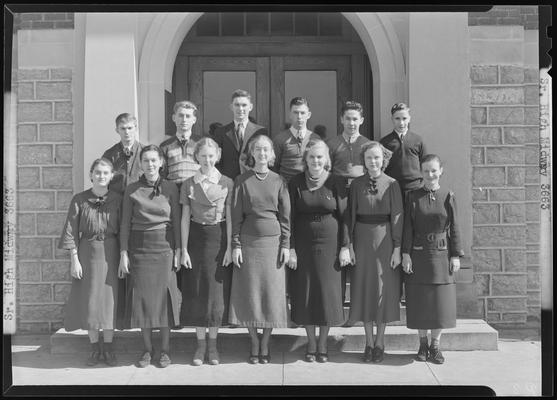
[405, 283, 456, 329]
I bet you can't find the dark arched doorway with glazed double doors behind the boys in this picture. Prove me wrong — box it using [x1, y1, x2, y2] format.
[165, 12, 373, 141]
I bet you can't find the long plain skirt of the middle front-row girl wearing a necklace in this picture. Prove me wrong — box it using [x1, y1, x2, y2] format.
[228, 235, 288, 328]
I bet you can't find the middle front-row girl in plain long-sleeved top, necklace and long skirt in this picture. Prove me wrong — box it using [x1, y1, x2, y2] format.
[229, 135, 290, 364]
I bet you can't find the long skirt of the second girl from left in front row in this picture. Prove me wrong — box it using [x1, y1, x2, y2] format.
[127, 229, 181, 328]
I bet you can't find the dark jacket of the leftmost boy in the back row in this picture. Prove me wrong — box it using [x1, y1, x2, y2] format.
[103, 140, 143, 195]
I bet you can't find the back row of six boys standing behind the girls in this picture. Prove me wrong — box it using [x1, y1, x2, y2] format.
[103, 90, 427, 198]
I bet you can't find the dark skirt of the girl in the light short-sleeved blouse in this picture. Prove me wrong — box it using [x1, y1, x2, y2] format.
[180, 221, 232, 327]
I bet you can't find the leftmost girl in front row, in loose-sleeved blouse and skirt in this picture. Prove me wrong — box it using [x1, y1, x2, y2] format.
[58, 158, 122, 366]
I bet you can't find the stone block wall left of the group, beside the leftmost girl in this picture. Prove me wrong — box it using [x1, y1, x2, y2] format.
[14, 68, 73, 332]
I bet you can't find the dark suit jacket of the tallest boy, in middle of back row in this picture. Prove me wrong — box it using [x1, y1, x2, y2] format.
[214, 121, 268, 180]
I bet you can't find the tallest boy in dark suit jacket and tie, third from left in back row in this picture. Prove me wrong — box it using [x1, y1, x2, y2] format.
[214, 89, 268, 179]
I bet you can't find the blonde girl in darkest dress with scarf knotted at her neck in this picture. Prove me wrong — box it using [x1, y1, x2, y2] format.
[288, 140, 350, 362]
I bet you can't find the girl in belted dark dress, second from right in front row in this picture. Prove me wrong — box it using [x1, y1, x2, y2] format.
[348, 142, 403, 362]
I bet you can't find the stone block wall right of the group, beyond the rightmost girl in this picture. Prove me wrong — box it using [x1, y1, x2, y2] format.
[470, 65, 540, 324]
